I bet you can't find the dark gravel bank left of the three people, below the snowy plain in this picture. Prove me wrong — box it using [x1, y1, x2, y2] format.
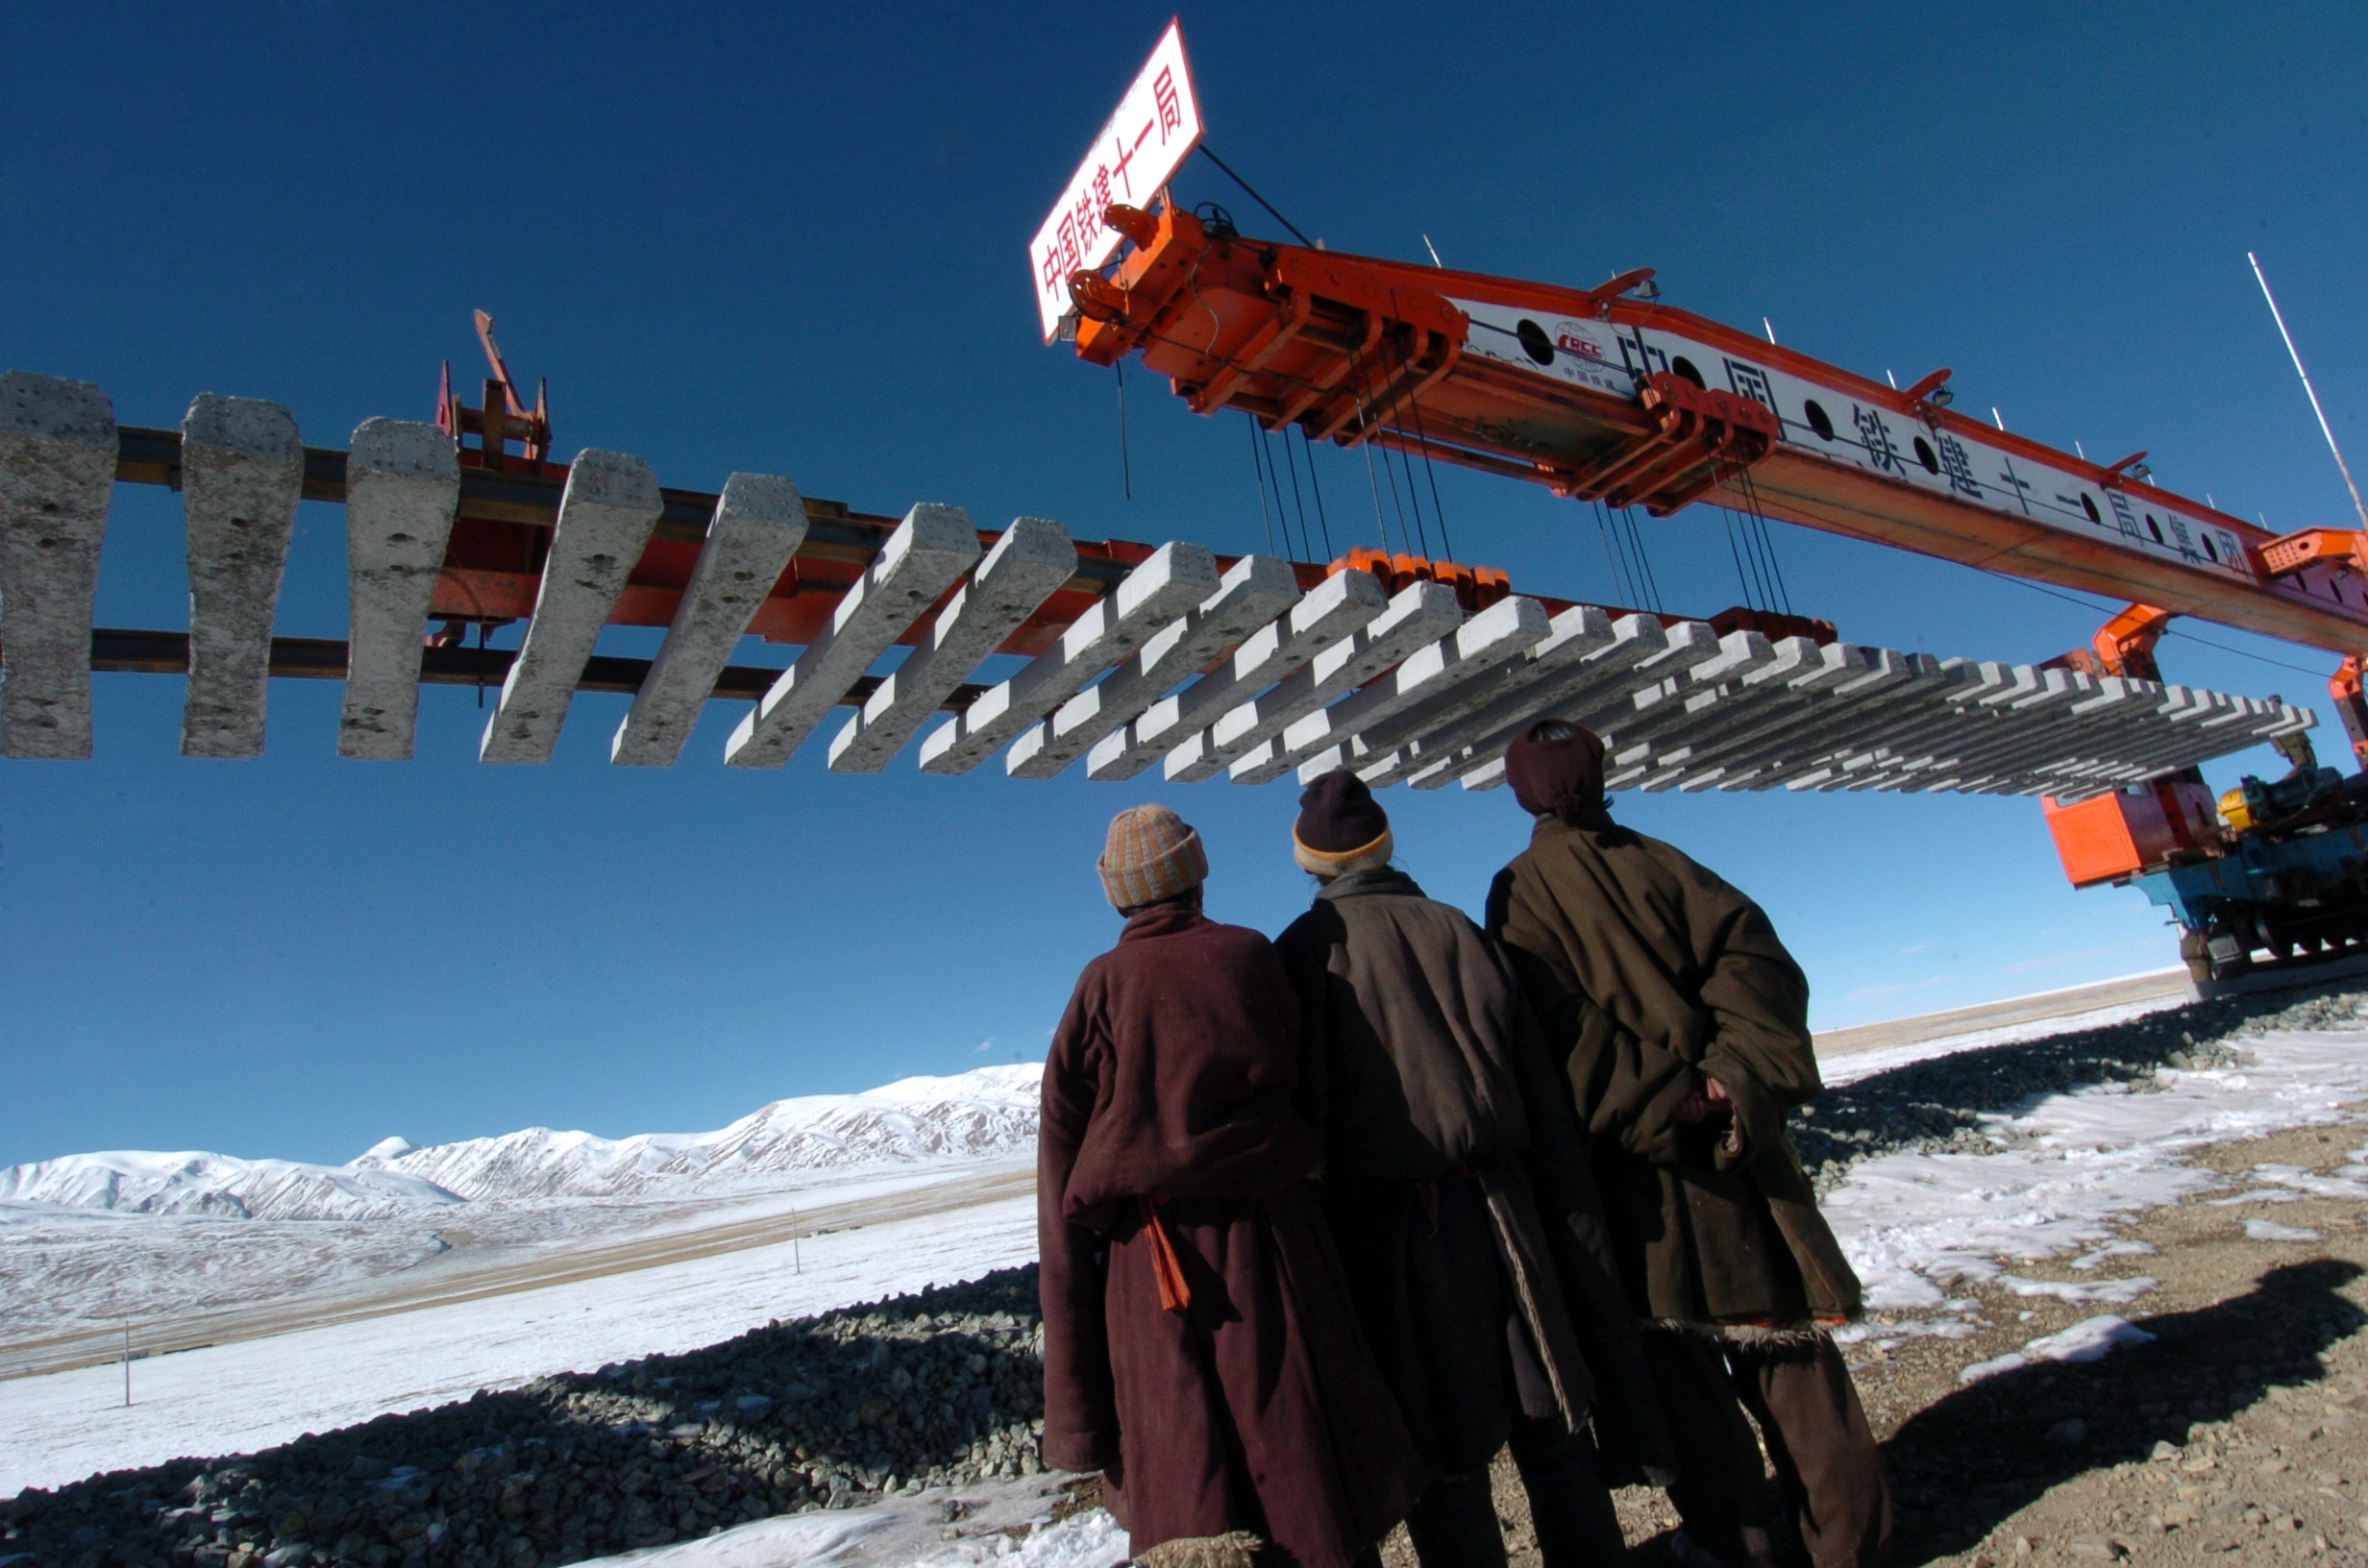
[0, 1264, 1045, 1568]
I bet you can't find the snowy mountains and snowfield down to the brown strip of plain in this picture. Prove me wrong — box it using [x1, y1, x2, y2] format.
[0, 1066, 1042, 1376]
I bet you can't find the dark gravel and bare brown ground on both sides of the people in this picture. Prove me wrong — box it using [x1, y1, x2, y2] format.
[13, 990, 2368, 1568]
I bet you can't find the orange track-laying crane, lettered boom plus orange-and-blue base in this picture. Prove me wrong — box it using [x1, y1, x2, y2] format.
[1061, 202, 2368, 978]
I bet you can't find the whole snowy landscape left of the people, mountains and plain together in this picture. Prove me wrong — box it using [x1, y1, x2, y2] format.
[0, 1066, 1042, 1497]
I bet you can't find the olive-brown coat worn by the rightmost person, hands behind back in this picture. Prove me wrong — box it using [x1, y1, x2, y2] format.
[1487, 813, 1859, 1327]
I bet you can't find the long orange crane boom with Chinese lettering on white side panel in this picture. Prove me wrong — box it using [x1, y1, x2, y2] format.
[1071, 208, 2368, 653]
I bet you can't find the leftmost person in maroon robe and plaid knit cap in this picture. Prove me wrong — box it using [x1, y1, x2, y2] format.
[1037, 805, 1428, 1568]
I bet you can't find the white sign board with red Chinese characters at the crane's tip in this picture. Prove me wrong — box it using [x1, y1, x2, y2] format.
[1027, 21, 1200, 343]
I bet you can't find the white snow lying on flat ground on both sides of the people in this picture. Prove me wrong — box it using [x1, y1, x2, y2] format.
[0, 994, 2368, 1568]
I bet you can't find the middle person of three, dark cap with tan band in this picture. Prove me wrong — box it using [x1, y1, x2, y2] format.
[1276, 772, 1669, 1568]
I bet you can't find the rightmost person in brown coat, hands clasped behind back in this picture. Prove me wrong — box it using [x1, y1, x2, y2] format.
[1487, 718, 1892, 1568]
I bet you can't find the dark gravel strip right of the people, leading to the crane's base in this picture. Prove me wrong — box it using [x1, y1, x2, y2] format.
[1790, 983, 2368, 1191]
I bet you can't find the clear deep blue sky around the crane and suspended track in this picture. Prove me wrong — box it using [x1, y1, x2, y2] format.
[0, 5, 2368, 1163]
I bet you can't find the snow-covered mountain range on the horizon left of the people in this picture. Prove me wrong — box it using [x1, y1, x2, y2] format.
[0, 1064, 1045, 1220]
